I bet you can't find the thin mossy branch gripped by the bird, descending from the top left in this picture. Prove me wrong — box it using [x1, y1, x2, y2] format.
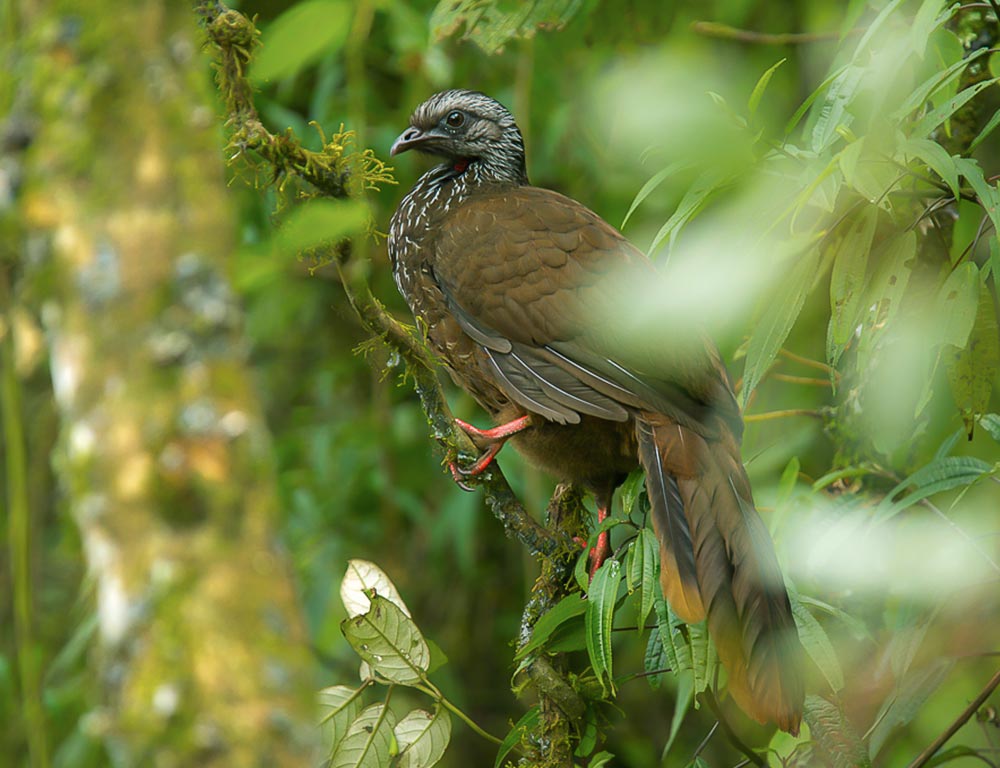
[195, 0, 568, 555]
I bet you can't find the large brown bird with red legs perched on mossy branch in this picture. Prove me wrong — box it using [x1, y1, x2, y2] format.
[387, 89, 804, 733]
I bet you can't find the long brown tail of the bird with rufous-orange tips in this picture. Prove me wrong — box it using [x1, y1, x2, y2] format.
[636, 414, 803, 733]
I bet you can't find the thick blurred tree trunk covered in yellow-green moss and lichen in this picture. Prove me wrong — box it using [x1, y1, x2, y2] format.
[17, 0, 318, 766]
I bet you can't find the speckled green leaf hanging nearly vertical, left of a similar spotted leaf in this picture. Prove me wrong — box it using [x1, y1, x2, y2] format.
[830, 205, 878, 350]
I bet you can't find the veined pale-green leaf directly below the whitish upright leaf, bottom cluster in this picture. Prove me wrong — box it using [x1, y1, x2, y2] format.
[340, 595, 430, 685]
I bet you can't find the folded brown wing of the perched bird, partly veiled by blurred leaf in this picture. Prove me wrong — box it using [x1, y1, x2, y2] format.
[430, 187, 739, 431]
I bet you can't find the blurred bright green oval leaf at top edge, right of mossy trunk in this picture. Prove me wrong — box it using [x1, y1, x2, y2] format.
[250, 0, 352, 82]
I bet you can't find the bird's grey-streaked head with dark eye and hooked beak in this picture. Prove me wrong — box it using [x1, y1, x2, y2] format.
[389, 90, 527, 183]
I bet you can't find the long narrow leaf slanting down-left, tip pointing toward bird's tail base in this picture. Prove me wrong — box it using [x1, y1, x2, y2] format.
[740, 248, 820, 408]
